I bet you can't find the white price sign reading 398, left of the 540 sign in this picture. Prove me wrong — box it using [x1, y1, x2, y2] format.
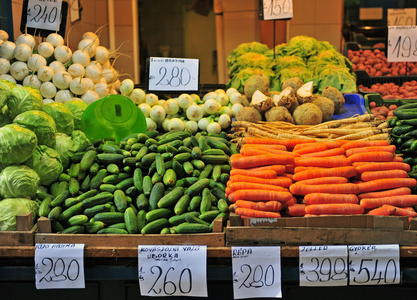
[299, 246, 348, 286]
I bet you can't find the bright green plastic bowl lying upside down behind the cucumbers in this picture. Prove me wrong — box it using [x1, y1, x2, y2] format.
[81, 95, 146, 142]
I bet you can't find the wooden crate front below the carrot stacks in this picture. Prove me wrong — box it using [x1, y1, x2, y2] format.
[226, 215, 417, 246]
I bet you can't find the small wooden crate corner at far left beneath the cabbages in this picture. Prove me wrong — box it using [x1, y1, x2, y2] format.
[0, 212, 37, 247]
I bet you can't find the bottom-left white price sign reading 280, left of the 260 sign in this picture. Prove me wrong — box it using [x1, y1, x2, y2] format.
[35, 244, 85, 289]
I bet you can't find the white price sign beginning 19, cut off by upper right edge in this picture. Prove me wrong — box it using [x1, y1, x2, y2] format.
[387, 26, 417, 62]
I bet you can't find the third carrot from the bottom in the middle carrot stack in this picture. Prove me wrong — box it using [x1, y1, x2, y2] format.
[290, 183, 359, 196]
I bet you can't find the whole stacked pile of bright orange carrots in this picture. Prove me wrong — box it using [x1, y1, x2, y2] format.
[226, 137, 417, 218]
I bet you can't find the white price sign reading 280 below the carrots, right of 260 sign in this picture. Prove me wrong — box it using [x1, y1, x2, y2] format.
[232, 247, 282, 299]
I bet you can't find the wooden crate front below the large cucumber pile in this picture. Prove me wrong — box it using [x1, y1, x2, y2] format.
[35, 218, 225, 248]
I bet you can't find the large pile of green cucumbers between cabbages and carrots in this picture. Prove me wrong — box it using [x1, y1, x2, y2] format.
[38, 130, 238, 234]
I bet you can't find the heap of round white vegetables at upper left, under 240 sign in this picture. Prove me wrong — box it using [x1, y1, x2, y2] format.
[0, 30, 121, 104]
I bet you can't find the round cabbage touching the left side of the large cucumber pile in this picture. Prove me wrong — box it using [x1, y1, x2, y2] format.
[25, 145, 64, 186]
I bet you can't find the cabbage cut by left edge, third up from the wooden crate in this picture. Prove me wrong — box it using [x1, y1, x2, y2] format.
[0, 124, 38, 165]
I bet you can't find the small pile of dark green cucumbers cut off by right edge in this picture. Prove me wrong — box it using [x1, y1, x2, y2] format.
[388, 103, 417, 178]
